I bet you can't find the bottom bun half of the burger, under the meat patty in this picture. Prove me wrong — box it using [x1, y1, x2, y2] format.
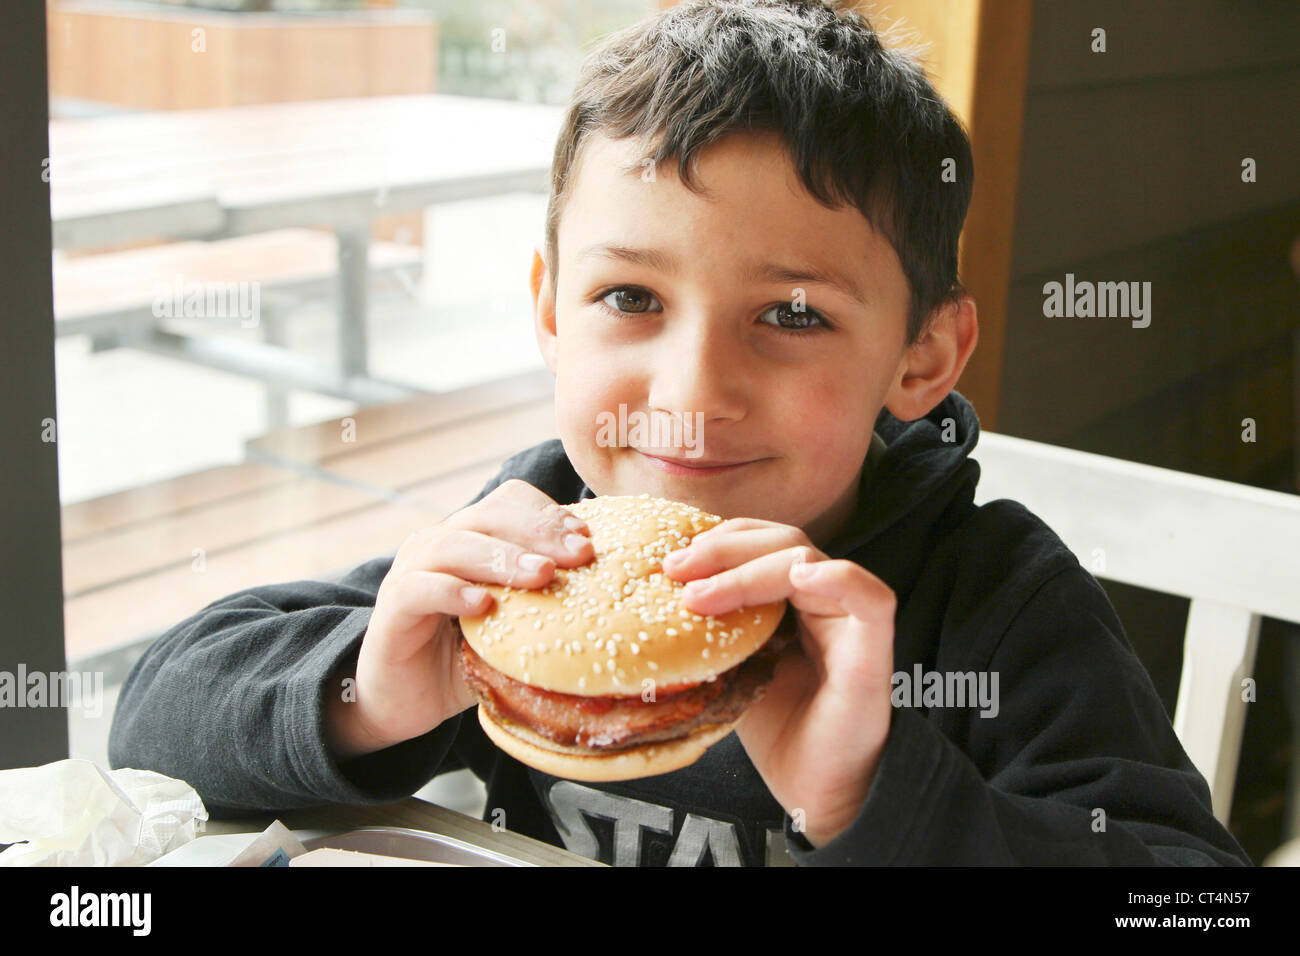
[478, 704, 736, 782]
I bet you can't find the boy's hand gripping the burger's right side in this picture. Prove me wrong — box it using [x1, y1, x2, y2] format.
[663, 518, 897, 847]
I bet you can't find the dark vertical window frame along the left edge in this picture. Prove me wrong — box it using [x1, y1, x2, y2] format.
[0, 0, 68, 769]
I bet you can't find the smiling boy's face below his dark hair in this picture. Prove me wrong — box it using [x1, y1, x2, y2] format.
[534, 133, 909, 546]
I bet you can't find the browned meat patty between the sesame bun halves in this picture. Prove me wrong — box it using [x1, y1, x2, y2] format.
[460, 635, 785, 752]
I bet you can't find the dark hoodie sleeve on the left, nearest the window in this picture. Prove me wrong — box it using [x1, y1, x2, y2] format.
[108, 558, 460, 818]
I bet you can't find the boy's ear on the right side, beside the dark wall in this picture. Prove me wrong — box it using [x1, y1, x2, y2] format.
[885, 293, 979, 421]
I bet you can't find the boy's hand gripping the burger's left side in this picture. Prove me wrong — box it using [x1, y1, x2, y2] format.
[325, 479, 595, 760]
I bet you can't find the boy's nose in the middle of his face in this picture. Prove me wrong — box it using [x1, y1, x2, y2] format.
[647, 320, 746, 423]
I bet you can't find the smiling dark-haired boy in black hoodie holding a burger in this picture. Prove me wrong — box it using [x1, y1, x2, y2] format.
[111, 0, 1249, 865]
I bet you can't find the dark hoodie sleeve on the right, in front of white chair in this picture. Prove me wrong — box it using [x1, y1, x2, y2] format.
[785, 562, 1251, 866]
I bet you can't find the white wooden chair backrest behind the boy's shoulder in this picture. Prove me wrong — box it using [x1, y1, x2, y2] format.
[971, 432, 1300, 825]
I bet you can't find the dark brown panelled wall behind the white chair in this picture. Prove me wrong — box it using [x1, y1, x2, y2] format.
[998, 0, 1300, 862]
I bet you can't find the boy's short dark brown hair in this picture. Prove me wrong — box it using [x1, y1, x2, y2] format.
[546, 0, 974, 345]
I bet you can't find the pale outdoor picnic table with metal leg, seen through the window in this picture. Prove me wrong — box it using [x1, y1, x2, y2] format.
[49, 94, 563, 405]
